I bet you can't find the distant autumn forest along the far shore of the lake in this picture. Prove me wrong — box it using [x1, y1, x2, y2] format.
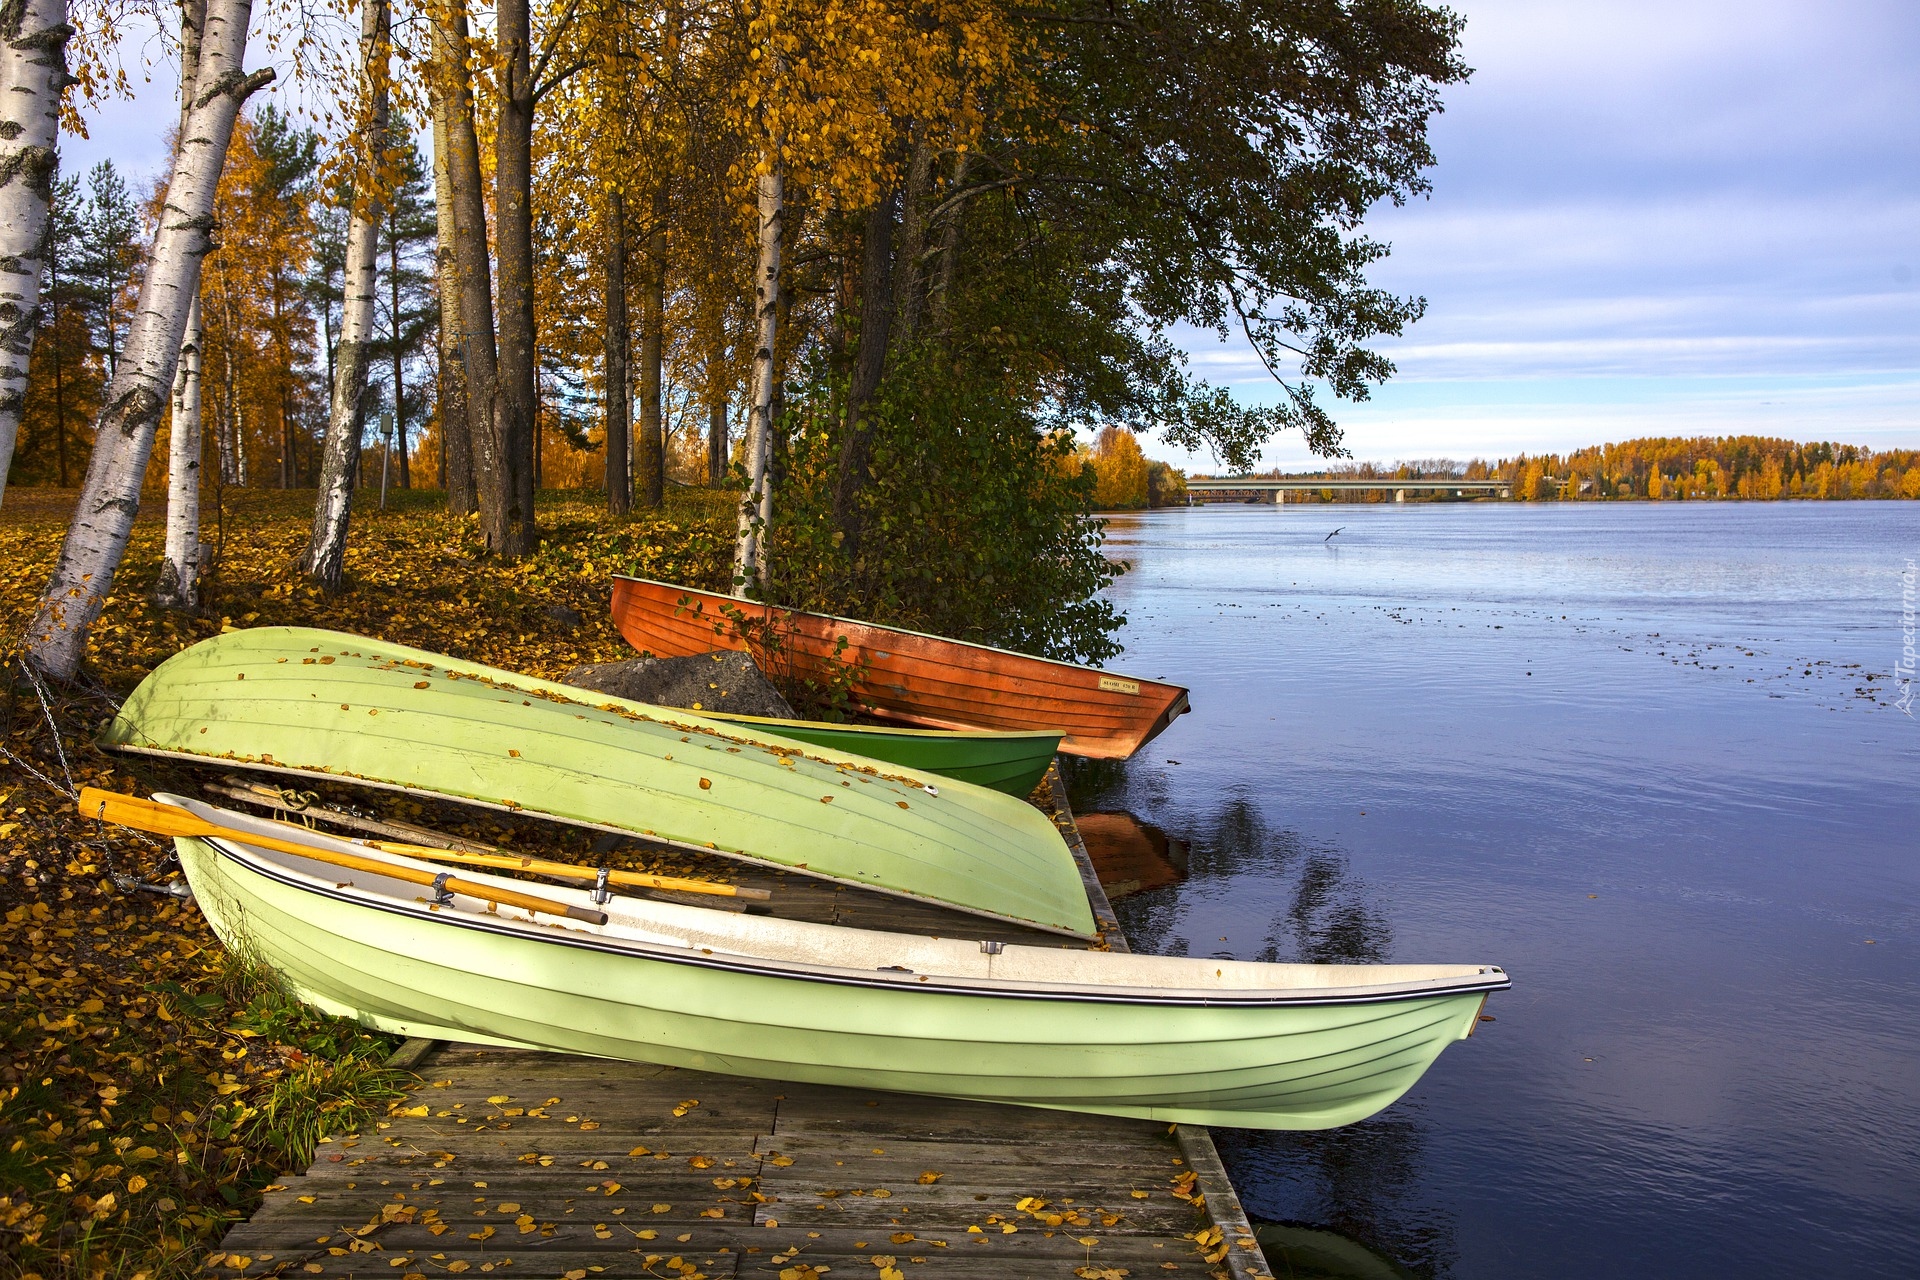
[1213, 436, 1920, 503]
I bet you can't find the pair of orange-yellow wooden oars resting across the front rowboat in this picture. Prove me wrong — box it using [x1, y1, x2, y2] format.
[79, 787, 772, 925]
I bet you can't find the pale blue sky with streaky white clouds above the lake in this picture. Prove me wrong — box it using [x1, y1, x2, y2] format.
[65, 0, 1920, 466]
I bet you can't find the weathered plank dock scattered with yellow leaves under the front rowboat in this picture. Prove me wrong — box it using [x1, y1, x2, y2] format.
[209, 773, 1267, 1280]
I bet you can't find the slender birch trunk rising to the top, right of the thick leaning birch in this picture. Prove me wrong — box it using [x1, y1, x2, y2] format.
[305, 0, 390, 589]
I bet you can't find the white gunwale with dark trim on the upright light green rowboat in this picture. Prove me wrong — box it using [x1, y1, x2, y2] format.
[183, 796, 1513, 1009]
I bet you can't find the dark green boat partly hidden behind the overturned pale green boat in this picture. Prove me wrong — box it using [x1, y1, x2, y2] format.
[699, 710, 1066, 800]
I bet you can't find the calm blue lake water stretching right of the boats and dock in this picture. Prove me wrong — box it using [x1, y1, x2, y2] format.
[1071, 503, 1920, 1278]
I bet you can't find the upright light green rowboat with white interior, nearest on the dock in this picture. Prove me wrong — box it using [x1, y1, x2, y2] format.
[159, 796, 1507, 1128]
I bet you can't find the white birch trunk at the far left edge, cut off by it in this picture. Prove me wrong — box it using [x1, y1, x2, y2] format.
[0, 0, 73, 501]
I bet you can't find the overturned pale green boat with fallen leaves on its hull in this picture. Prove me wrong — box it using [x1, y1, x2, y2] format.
[104, 628, 1096, 936]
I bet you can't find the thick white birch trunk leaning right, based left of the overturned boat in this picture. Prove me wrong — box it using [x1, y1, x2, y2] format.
[27, 0, 273, 681]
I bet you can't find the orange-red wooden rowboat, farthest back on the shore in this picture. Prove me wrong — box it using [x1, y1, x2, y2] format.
[612, 574, 1190, 760]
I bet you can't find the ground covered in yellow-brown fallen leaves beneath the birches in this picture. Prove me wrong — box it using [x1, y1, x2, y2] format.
[0, 489, 732, 1280]
